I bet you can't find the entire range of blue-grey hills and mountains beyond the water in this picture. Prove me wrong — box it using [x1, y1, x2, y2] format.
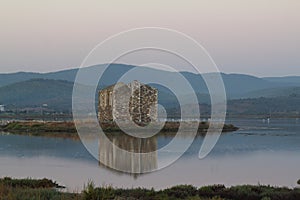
[0, 64, 300, 114]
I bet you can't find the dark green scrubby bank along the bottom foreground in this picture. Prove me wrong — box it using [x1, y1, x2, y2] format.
[0, 178, 300, 200]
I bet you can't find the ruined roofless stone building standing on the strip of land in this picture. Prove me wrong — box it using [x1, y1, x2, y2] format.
[98, 81, 158, 124]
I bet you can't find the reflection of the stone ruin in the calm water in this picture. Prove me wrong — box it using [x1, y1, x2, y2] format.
[99, 135, 158, 173]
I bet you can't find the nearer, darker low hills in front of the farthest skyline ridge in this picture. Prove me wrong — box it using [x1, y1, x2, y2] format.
[0, 79, 300, 116]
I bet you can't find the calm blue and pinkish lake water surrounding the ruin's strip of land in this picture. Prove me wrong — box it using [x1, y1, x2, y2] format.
[0, 119, 300, 192]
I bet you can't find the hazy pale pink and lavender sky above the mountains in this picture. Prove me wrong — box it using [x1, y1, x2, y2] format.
[0, 0, 300, 76]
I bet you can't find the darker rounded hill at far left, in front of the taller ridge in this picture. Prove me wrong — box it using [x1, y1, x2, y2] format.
[0, 79, 73, 111]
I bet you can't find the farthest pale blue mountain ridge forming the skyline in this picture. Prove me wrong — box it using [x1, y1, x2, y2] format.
[0, 64, 300, 99]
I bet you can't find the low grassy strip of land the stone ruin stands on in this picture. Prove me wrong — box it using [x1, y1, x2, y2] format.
[0, 121, 238, 139]
